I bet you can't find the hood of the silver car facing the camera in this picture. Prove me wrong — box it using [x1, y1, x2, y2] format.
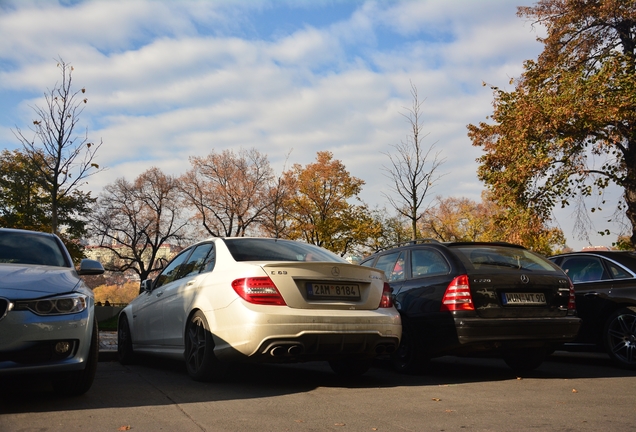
[0, 264, 81, 300]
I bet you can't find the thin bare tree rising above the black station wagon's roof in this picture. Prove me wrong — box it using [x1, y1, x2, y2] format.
[383, 83, 445, 240]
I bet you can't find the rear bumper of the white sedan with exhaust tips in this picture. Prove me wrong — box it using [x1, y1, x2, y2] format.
[211, 309, 402, 362]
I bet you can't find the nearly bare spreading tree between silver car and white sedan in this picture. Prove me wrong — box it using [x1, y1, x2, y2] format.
[91, 168, 188, 280]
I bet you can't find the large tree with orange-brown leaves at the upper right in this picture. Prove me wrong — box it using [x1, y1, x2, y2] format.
[468, 0, 636, 247]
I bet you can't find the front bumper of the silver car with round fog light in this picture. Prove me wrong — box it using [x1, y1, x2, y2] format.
[0, 310, 94, 375]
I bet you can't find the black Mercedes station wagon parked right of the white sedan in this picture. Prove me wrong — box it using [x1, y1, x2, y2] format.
[361, 240, 580, 373]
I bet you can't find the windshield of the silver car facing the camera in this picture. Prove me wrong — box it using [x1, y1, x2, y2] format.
[0, 231, 69, 267]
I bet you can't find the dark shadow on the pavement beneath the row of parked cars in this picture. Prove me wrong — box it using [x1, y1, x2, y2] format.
[0, 352, 636, 414]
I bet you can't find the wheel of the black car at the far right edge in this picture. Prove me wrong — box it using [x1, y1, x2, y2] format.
[603, 306, 636, 369]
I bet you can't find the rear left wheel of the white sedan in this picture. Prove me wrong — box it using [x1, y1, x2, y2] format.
[184, 311, 228, 381]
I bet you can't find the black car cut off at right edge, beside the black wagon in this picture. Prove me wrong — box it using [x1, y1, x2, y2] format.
[550, 251, 636, 369]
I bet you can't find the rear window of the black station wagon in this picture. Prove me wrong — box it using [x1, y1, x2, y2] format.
[453, 245, 560, 272]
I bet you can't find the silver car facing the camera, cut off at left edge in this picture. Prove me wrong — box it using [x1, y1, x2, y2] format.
[0, 228, 104, 395]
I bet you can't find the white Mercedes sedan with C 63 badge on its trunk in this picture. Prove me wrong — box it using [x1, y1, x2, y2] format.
[118, 237, 402, 381]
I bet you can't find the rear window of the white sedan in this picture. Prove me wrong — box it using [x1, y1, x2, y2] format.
[225, 238, 348, 263]
